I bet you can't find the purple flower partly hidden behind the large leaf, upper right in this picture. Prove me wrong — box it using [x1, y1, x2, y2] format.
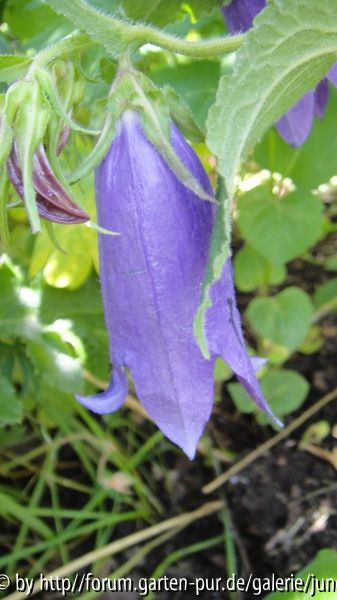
[222, 0, 337, 146]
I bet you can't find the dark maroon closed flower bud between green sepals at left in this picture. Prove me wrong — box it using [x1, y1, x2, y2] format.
[7, 143, 90, 224]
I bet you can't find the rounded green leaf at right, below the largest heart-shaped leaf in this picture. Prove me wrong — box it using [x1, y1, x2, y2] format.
[247, 287, 313, 351]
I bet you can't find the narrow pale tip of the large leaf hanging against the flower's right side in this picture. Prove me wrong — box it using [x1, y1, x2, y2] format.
[193, 177, 231, 359]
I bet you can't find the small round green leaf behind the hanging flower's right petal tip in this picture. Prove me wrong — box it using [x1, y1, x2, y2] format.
[227, 369, 309, 424]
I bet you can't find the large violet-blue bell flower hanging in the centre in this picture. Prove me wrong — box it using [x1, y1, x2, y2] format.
[77, 109, 273, 459]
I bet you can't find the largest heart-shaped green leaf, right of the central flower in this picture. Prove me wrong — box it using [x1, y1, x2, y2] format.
[238, 184, 322, 266]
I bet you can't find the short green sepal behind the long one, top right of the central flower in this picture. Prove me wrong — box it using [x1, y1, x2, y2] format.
[162, 85, 205, 143]
